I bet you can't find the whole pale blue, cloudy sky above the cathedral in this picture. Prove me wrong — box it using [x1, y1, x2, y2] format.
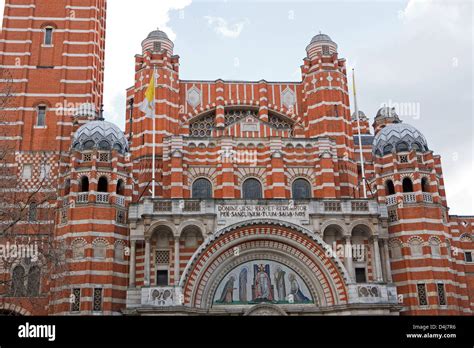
[0, 0, 474, 215]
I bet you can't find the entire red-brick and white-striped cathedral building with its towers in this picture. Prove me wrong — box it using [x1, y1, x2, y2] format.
[0, 0, 474, 316]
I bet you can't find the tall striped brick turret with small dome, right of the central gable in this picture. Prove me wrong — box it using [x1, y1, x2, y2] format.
[302, 33, 359, 198]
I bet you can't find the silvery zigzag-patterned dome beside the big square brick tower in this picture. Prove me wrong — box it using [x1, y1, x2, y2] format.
[72, 121, 129, 154]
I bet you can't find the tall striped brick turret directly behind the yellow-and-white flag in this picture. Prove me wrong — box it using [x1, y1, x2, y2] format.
[126, 29, 182, 198]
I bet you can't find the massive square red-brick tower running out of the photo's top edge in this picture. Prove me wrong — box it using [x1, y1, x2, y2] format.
[0, 0, 106, 314]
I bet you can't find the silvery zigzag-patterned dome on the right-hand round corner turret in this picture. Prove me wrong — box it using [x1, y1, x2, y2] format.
[373, 123, 429, 156]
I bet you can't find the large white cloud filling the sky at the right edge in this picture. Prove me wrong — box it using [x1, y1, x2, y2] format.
[348, 0, 474, 215]
